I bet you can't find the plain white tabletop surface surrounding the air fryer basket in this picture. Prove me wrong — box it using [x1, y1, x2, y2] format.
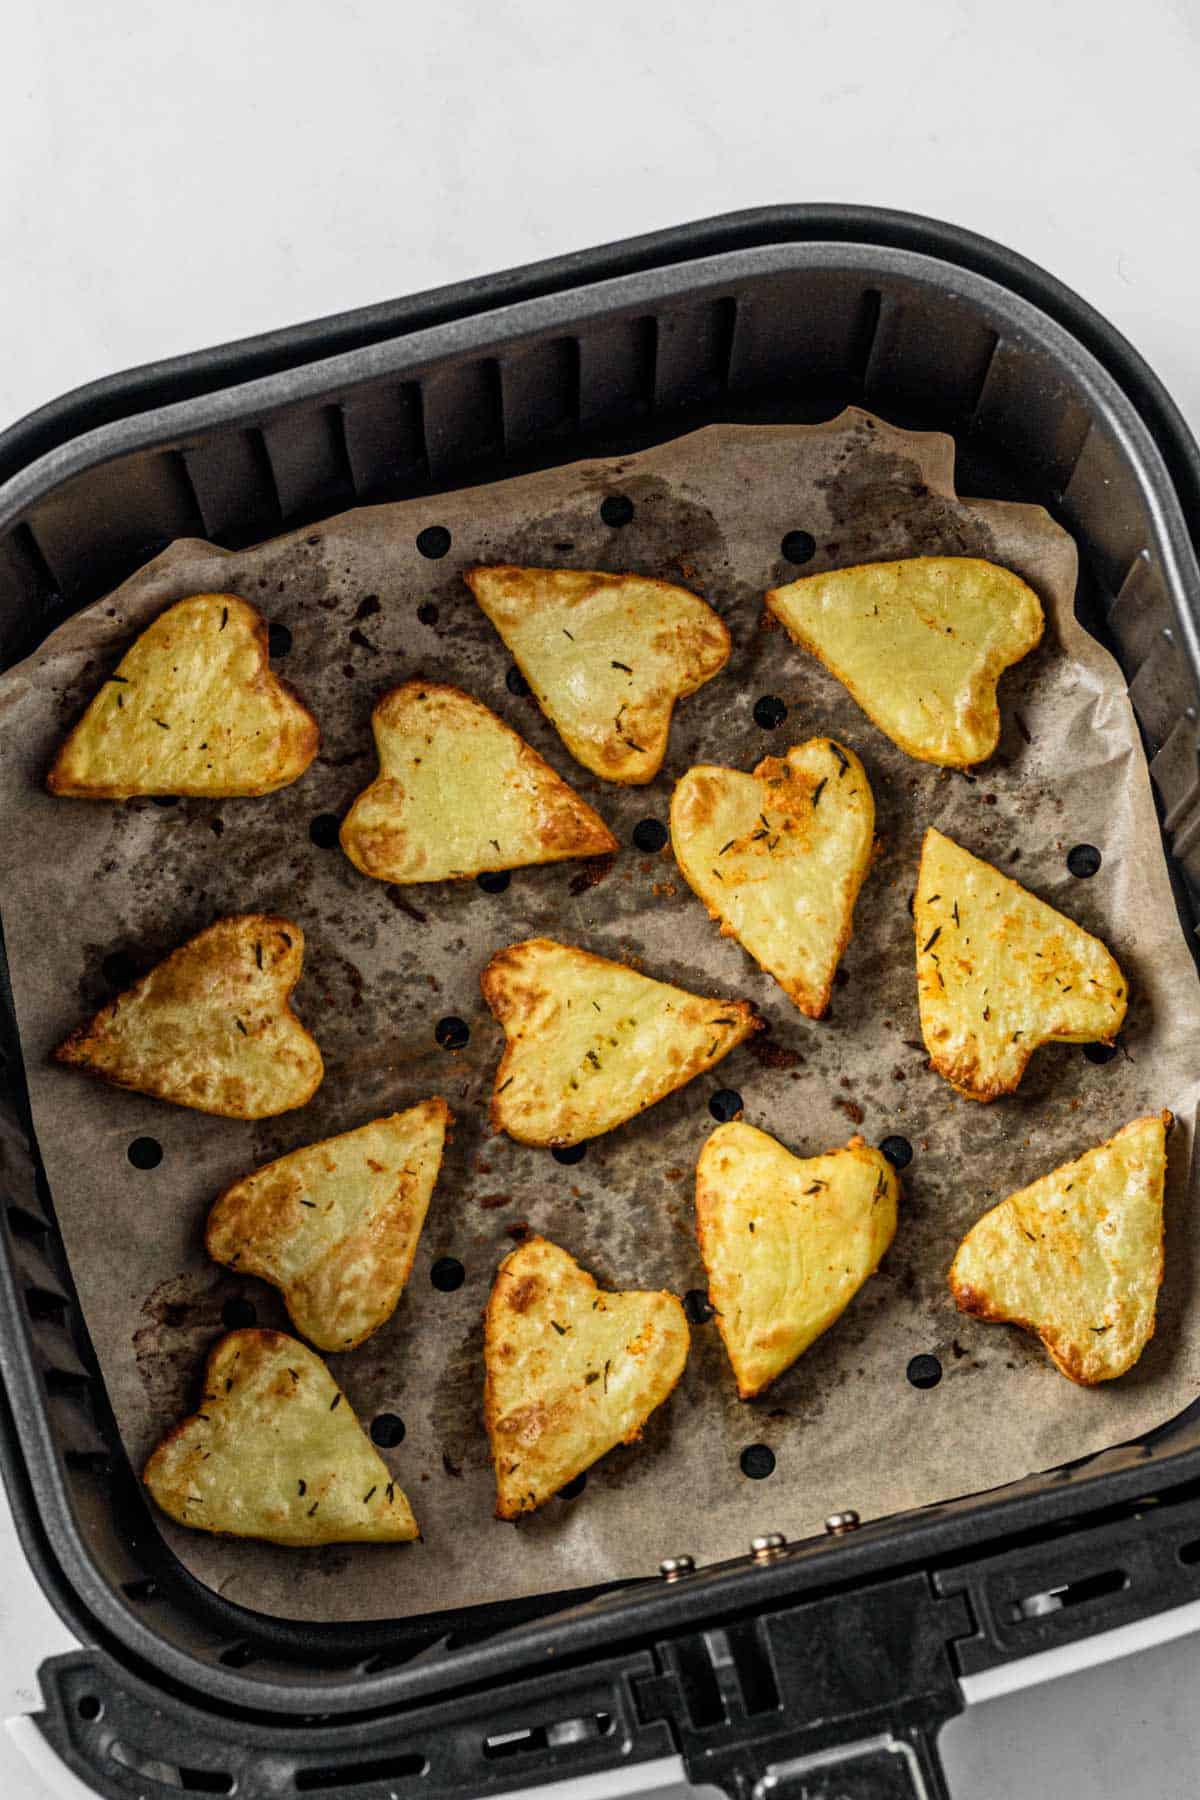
[0, 0, 1200, 1800]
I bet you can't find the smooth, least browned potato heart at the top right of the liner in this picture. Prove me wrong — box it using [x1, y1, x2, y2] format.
[766, 556, 1043, 769]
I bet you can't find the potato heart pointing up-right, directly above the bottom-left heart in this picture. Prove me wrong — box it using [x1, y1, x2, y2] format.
[205, 1098, 453, 1350]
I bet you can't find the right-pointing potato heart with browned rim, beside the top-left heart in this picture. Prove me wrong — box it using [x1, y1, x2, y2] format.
[342, 680, 619, 882]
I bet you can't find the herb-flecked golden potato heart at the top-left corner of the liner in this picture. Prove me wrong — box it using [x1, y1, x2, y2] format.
[47, 594, 320, 799]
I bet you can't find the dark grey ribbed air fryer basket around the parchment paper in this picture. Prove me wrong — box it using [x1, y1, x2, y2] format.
[0, 207, 1200, 1793]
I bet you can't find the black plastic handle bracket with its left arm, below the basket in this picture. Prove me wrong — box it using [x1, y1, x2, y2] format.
[36, 1573, 970, 1800]
